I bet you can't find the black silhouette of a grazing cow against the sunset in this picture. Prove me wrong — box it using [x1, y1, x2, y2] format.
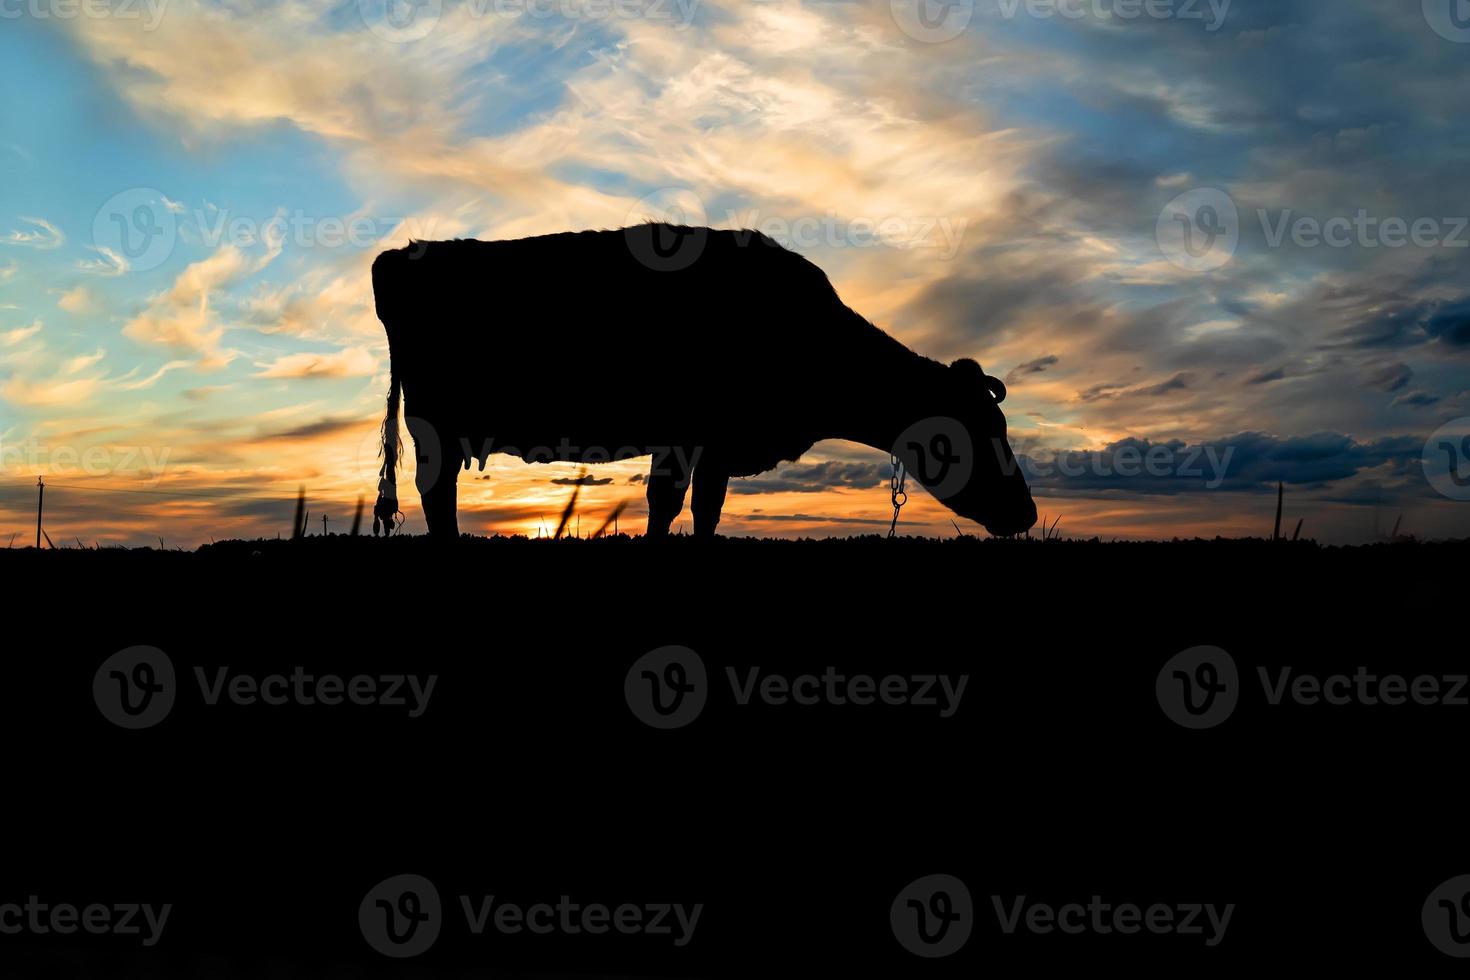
[372, 223, 1036, 538]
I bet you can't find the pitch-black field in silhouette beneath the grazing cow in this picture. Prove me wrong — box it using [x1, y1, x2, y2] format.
[0, 538, 1470, 977]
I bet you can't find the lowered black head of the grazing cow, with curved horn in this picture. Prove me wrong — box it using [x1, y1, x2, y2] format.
[894, 359, 1036, 535]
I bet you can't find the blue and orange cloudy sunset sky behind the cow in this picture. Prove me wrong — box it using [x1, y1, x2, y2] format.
[0, 0, 1470, 547]
